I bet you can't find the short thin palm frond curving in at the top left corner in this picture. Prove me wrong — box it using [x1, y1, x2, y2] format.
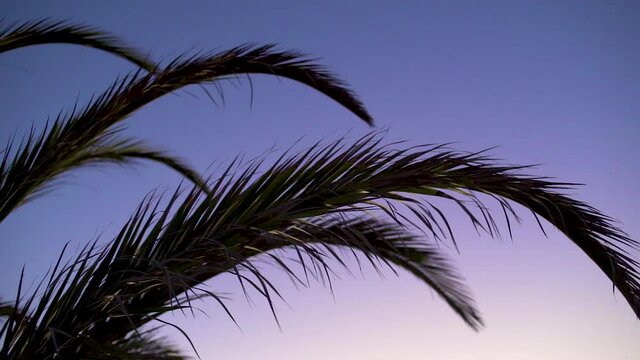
[0, 19, 157, 72]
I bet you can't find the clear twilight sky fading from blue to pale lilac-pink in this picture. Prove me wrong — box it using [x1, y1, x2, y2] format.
[0, 0, 640, 360]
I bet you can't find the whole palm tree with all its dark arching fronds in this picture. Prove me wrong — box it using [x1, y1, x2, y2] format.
[0, 20, 640, 359]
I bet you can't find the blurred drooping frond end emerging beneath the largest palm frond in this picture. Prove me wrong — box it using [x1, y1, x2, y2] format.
[276, 214, 482, 329]
